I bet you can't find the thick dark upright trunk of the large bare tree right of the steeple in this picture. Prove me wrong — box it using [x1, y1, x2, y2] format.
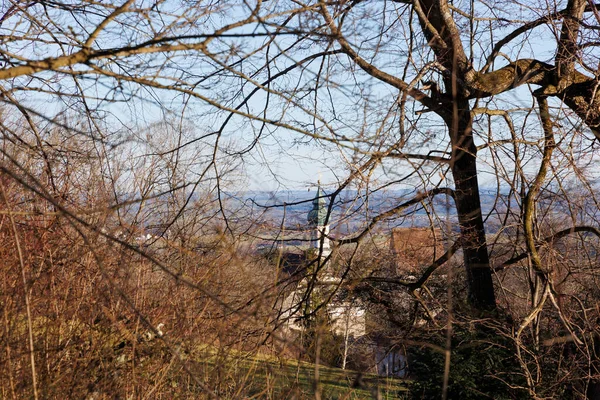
[414, 0, 500, 311]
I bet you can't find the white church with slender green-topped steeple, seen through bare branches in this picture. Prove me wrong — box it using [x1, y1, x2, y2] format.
[280, 186, 406, 376]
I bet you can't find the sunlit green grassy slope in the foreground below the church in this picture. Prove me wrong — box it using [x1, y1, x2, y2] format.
[16, 318, 407, 399]
